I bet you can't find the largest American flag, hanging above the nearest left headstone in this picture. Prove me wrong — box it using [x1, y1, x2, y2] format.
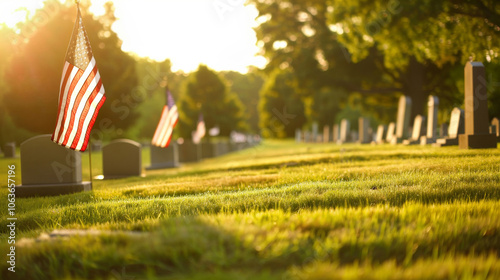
[52, 8, 106, 151]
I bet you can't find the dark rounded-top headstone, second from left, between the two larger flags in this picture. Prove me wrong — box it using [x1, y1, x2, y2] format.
[102, 139, 142, 179]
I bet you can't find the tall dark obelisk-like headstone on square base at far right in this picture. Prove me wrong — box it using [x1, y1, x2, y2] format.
[458, 62, 497, 149]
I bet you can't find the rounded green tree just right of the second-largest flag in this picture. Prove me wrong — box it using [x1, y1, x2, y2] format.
[178, 65, 248, 139]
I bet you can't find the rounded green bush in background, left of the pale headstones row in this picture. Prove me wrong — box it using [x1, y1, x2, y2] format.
[259, 70, 306, 138]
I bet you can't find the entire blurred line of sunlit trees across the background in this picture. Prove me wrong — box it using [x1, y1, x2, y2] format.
[0, 0, 500, 144]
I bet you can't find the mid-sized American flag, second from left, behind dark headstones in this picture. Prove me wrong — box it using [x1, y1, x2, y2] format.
[151, 90, 179, 148]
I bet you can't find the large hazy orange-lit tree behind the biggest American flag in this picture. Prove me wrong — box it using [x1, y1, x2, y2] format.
[5, 1, 137, 139]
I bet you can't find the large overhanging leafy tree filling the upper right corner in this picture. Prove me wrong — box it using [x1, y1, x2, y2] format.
[248, 0, 500, 119]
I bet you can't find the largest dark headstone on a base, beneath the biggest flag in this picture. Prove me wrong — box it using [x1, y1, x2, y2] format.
[16, 134, 92, 197]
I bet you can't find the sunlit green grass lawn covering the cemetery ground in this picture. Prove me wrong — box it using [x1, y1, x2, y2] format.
[0, 141, 500, 279]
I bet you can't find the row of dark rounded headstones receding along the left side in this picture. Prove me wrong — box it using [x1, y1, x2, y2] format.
[14, 134, 259, 197]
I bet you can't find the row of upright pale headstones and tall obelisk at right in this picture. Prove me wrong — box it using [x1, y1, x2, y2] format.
[296, 62, 500, 149]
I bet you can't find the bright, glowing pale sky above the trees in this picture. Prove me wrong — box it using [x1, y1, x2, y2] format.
[0, 0, 266, 73]
